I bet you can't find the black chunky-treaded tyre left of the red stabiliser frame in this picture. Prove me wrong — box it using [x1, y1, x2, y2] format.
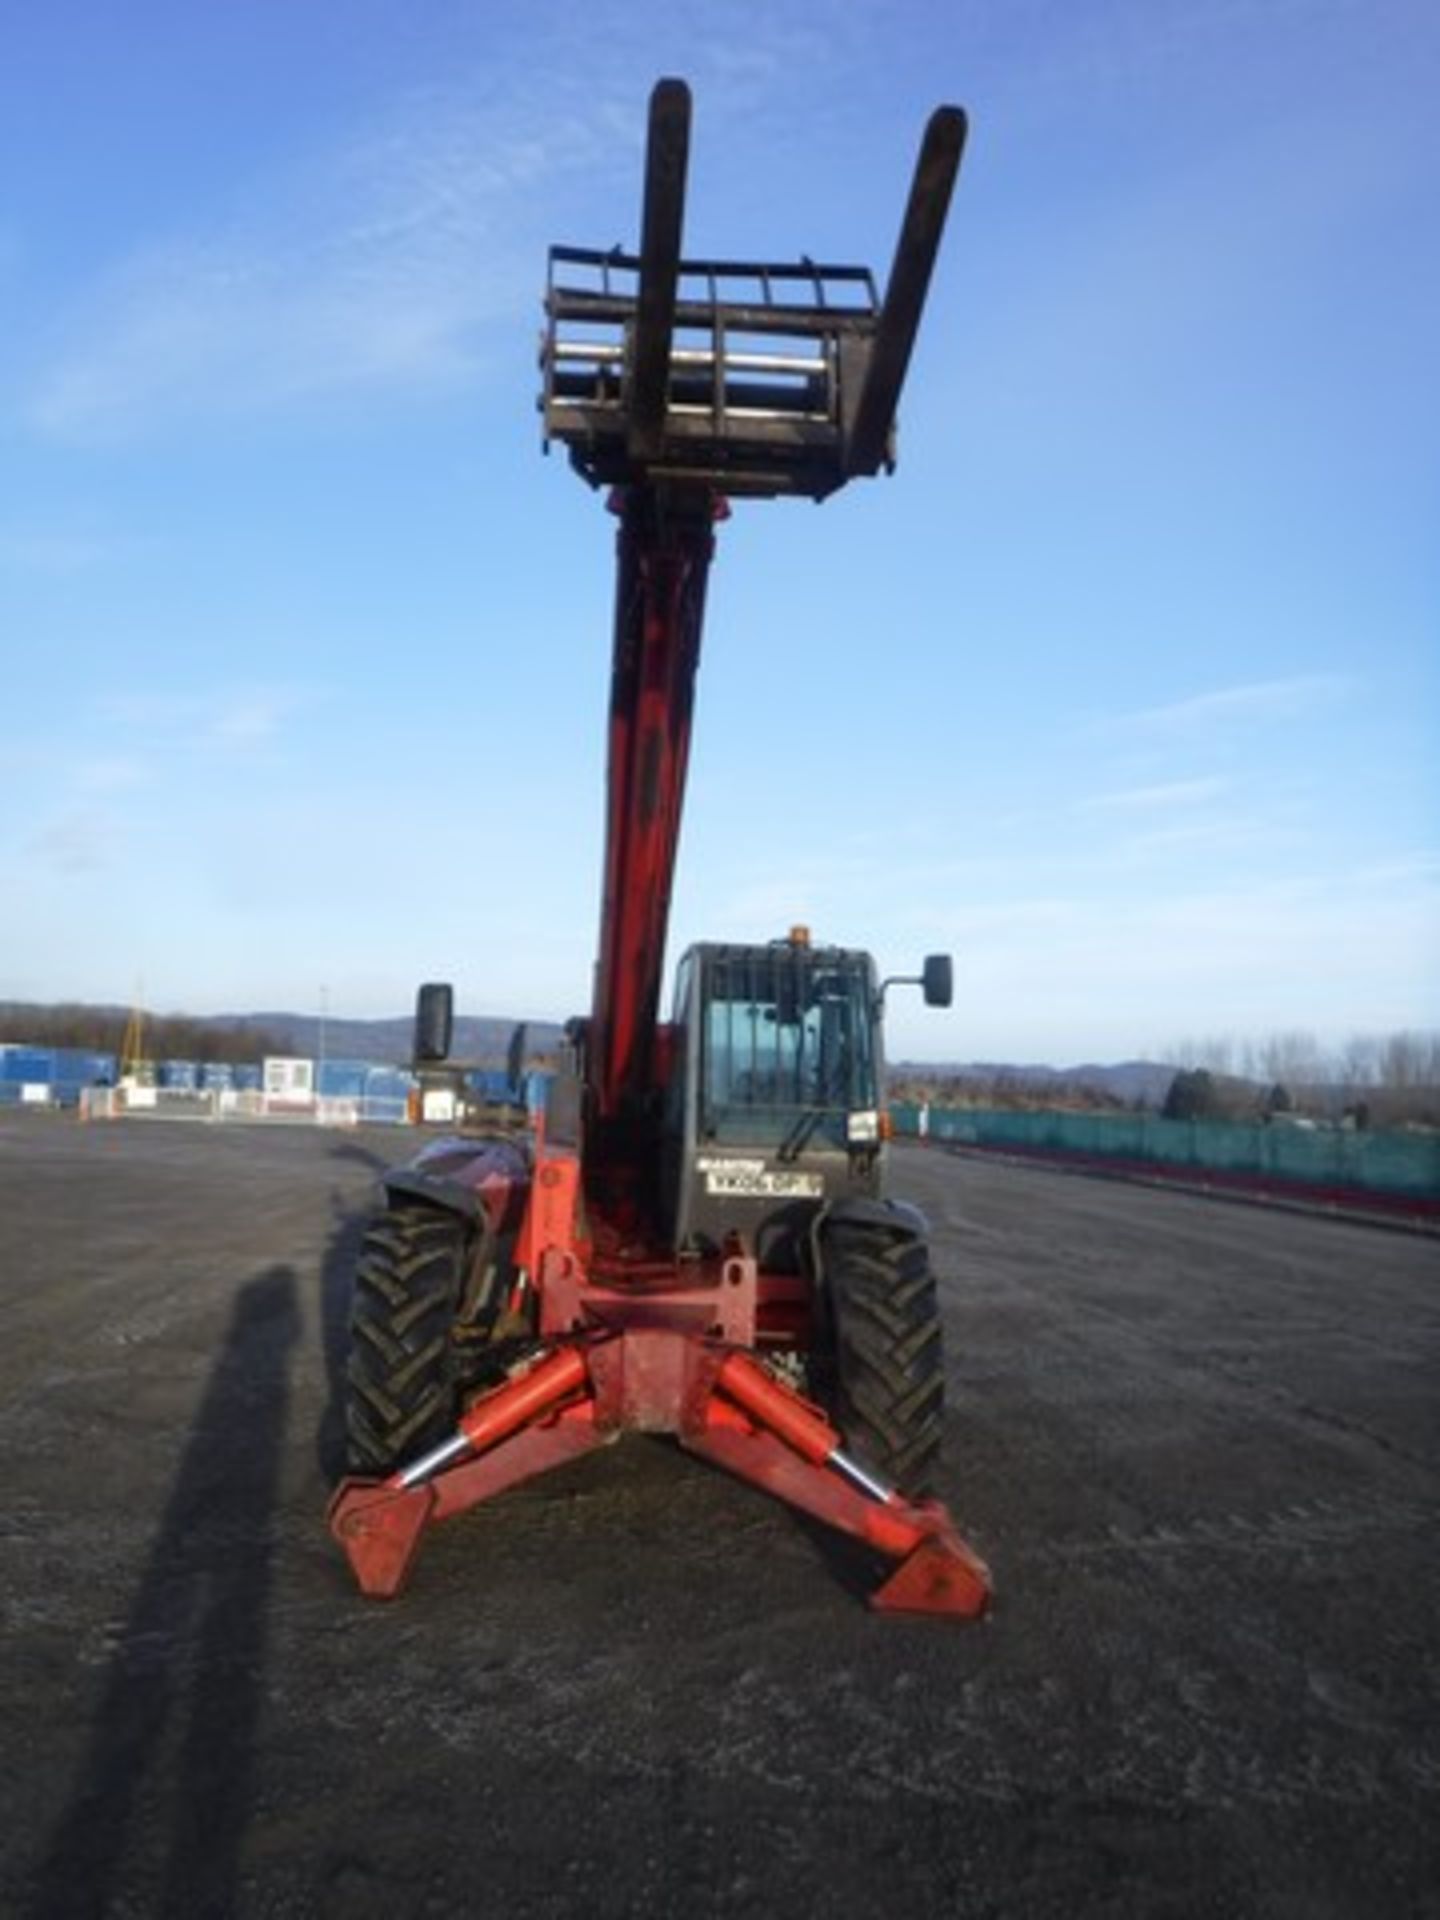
[346, 1206, 474, 1475]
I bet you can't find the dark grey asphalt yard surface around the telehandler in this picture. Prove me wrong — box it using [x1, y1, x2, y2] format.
[0, 1114, 1440, 1920]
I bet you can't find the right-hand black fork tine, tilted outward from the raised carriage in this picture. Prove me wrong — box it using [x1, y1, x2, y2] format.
[845, 108, 968, 474]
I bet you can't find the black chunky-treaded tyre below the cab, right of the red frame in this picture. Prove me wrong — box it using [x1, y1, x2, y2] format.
[822, 1219, 945, 1494]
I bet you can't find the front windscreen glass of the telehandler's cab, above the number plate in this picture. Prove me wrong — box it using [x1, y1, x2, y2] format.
[701, 947, 877, 1148]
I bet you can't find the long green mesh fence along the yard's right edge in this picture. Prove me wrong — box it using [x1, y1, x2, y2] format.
[893, 1106, 1440, 1200]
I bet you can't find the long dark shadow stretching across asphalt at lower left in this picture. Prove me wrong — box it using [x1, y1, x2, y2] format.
[29, 1267, 300, 1920]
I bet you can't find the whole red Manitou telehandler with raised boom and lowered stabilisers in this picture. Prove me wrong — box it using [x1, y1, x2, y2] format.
[330, 81, 989, 1617]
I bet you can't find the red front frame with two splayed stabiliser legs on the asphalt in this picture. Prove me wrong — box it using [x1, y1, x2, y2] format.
[330, 1152, 989, 1619]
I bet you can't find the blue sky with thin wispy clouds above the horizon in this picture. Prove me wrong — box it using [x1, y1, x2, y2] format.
[0, 0, 1440, 1064]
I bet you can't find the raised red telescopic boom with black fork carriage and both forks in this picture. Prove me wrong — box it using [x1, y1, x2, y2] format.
[541, 79, 966, 1129]
